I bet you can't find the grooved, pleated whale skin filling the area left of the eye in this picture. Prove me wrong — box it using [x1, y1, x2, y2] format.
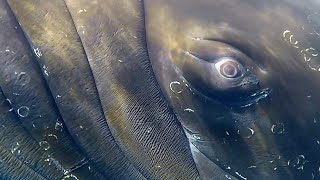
[0, 0, 199, 179]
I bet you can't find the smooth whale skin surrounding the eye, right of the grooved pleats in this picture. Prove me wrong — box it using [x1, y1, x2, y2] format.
[145, 0, 320, 179]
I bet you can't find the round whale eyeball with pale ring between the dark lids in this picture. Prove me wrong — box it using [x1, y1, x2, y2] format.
[215, 59, 243, 78]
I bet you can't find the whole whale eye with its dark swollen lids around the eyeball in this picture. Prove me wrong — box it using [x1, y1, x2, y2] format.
[171, 40, 269, 106]
